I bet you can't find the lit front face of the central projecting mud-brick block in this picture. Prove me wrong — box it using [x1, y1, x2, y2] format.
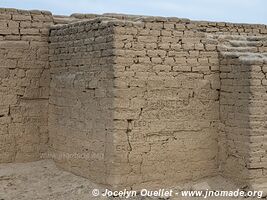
[111, 22, 220, 188]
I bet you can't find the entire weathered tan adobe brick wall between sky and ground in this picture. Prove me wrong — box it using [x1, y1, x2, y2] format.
[0, 9, 267, 192]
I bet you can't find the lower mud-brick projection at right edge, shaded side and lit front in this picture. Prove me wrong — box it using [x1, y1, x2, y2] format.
[220, 55, 267, 185]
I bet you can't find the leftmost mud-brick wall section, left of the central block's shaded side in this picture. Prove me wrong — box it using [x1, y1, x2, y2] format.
[0, 9, 53, 162]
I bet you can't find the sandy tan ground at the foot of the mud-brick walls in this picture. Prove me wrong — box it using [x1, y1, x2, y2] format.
[0, 160, 264, 200]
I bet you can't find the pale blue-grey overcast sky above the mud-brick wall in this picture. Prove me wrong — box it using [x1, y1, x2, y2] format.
[0, 0, 267, 24]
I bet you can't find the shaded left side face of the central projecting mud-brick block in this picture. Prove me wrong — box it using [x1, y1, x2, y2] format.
[48, 20, 116, 185]
